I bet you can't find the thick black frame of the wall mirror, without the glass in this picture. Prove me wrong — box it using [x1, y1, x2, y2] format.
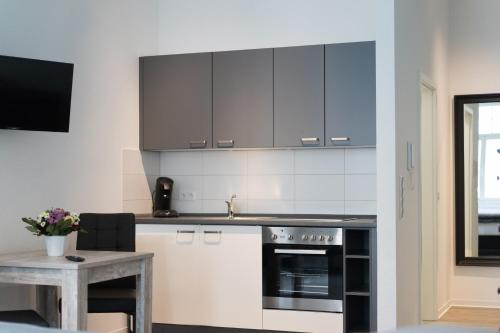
[454, 93, 500, 267]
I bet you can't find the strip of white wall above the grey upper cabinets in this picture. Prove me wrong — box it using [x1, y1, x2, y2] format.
[158, 0, 375, 54]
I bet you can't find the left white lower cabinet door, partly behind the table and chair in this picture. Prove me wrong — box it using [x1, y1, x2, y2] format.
[136, 225, 200, 325]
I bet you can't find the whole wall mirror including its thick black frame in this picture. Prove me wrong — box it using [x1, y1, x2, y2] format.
[455, 94, 500, 266]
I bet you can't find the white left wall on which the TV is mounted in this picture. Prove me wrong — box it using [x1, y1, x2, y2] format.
[0, 0, 158, 329]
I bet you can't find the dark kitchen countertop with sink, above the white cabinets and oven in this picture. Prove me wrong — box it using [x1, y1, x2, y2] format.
[136, 214, 377, 228]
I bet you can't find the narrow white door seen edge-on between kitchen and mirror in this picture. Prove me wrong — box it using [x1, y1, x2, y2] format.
[420, 80, 437, 320]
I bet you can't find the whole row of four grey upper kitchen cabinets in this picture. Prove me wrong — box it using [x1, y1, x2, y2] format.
[140, 42, 376, 150]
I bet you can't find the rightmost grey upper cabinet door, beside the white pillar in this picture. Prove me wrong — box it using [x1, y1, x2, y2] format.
[325, 42, 376, 146]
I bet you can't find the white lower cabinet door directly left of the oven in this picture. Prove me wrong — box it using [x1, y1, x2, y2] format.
[198, 226, 262, 329]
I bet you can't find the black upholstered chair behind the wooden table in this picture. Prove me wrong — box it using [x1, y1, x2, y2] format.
[76, 213, 136, 332]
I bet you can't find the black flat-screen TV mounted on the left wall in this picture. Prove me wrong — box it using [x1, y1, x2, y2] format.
[0, 56, 73, 132]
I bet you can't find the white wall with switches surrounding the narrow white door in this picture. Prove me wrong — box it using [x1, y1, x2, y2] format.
[395, 0, 451, 326]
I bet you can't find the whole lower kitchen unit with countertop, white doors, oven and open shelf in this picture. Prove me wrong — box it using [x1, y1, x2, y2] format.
[136, 216, 376, 333]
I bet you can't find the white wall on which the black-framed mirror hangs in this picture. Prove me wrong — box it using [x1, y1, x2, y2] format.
[449, 0, 500, 307]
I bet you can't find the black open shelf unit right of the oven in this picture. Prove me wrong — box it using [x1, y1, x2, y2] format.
[344, 228, 377, 333]
